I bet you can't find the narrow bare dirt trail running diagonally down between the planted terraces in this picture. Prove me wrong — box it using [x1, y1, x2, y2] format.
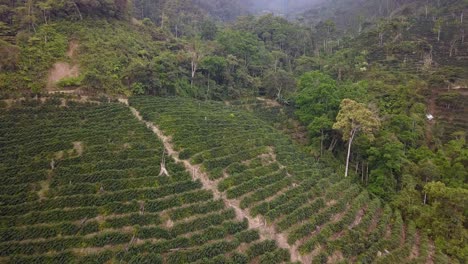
[119, 98, 305, 263]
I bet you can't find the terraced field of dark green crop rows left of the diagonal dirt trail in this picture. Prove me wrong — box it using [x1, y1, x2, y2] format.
[0, 99, 290, 263]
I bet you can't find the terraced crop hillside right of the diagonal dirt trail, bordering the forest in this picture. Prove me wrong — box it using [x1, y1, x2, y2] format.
[130, 97, 448, 263]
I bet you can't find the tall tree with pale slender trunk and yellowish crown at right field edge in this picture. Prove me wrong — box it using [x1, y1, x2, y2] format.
[333, 99, 380, 177]
